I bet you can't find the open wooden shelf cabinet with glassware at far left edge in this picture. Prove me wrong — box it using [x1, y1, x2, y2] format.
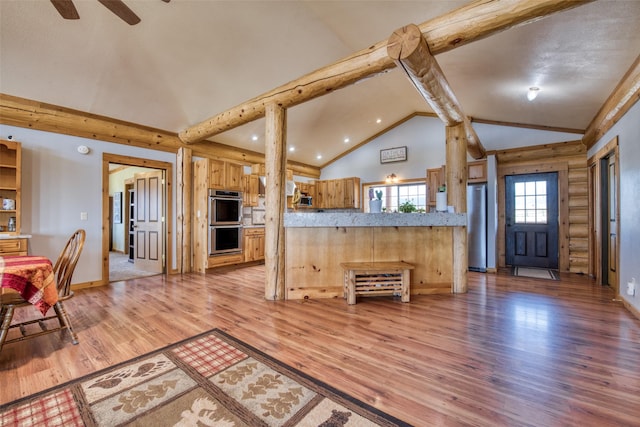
[0, 140, 22, 236]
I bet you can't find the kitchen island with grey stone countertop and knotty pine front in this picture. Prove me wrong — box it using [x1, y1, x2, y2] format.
[284, 212, 467, 299]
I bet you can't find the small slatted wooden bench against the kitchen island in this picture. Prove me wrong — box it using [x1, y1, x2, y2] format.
[340, 261, 415, 305]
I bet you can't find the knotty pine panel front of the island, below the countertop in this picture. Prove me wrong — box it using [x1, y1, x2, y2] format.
[285, 227, 455, 299]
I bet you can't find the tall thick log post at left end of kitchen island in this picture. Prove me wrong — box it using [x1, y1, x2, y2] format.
[264, 103, 287, 300]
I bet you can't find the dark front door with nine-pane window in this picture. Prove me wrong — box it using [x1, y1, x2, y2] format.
[505, 172, 558, 269]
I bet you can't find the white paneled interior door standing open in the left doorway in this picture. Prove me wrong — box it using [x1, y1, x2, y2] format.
[134, 171, 164, 273]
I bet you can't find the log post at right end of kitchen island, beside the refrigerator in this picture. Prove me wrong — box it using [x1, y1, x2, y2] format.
[446, 124, 469, 294]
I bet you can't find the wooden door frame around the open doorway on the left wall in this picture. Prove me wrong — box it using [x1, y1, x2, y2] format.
[101, 153, 173, 285]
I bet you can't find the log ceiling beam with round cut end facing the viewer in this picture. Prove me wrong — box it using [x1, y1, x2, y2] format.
[387, 24, 485, 159]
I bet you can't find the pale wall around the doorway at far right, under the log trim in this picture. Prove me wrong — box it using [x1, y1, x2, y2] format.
[588, 102, 640, 310]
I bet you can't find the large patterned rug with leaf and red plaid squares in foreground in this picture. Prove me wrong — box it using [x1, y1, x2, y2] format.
[0, 329, 408, 427]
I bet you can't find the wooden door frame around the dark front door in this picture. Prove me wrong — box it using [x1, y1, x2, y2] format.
[496, 161, 570, 272]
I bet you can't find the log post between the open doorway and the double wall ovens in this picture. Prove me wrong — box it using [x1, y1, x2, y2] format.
[176, 147, 193, 273]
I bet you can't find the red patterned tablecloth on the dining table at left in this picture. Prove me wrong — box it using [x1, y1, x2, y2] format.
[0, 256, 58, 316]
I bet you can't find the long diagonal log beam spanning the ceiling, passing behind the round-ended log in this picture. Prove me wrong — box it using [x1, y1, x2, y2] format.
[179, 0, 592, 143]
